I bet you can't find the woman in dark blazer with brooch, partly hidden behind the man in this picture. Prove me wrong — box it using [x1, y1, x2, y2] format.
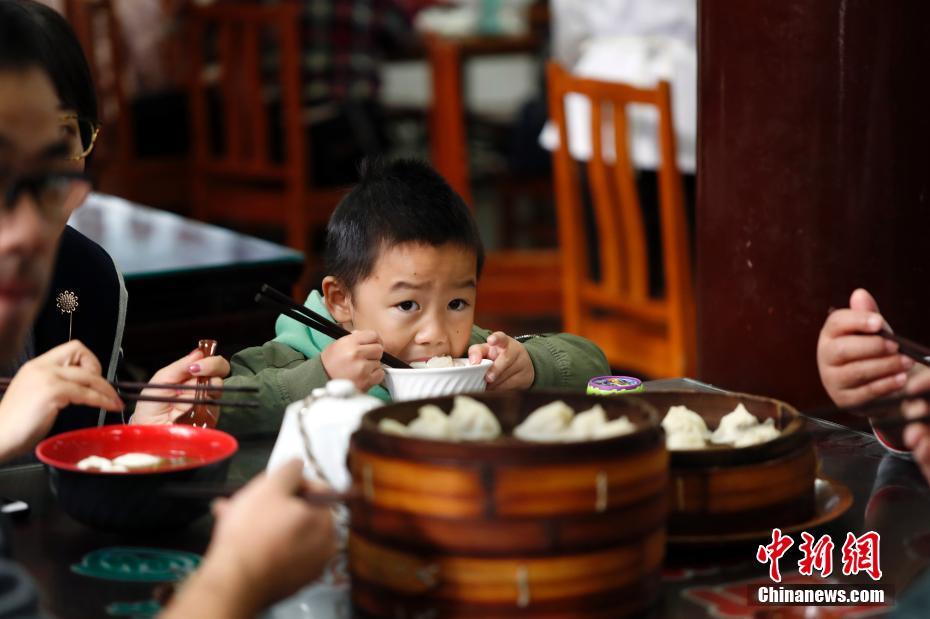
[0, 0, 229, 433]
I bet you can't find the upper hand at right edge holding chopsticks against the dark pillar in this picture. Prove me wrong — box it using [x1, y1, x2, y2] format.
[817, 288, 914, 406]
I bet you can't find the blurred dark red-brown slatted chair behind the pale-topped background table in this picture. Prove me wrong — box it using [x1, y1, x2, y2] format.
[188, 3, 342, 251]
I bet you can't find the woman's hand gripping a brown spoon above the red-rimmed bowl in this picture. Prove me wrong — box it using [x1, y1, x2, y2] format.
[129, 350, 229, 424]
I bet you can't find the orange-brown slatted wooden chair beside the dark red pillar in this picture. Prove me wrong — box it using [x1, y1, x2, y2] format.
[547, 63, 695, 378]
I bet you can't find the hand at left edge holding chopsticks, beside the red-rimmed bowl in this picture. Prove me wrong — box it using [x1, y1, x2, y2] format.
[0, 340, 123, 459]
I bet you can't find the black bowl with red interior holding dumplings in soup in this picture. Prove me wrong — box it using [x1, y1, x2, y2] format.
[36, 425, 239, 530]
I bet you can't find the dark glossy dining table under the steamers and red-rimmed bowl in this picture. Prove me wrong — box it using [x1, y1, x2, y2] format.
[0, 379, 930, 619]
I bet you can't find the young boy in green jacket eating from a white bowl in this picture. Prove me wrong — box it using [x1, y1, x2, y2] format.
[220, 160, 609, 432]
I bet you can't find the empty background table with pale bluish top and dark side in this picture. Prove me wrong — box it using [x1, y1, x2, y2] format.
[70, 194, 303, 372]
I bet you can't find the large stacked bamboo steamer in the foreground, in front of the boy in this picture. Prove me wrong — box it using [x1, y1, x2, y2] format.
[348, 392, 668, 619]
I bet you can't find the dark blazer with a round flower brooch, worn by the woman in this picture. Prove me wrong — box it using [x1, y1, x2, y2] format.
[32, 226, 128, 434]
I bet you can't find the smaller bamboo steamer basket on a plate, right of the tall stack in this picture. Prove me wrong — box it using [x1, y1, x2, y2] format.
[630, 390, 818, 540]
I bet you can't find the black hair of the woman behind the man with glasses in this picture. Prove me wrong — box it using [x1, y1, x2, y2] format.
[0, 0, 100, 123]
